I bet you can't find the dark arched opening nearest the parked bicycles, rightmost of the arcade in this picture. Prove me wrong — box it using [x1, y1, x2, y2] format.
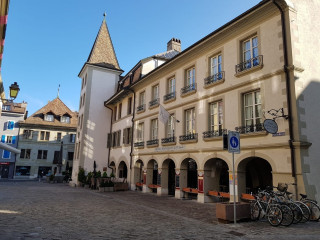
[238, 157, 273, 194]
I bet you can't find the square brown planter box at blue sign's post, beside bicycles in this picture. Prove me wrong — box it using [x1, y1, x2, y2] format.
[216, 202, 250, 222]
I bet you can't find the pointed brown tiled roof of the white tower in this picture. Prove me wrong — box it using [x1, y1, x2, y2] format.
[87, 15, 121, 70]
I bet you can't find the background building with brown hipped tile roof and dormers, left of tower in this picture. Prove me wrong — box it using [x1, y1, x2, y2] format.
[15, 97, 78, 178]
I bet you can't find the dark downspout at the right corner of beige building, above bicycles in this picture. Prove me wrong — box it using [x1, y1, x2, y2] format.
[272, 0, 298, 198]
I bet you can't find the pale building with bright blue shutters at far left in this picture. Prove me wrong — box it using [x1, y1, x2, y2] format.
[0, 102, 27, 178]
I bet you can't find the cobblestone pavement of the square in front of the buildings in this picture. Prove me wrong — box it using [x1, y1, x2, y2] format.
[0, 181, 320, 240]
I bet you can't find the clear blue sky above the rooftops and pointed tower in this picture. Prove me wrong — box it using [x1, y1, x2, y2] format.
[1, 0, 259, 116]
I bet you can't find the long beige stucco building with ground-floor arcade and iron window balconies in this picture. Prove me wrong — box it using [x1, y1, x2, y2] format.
[72, 0, 320, 202]
